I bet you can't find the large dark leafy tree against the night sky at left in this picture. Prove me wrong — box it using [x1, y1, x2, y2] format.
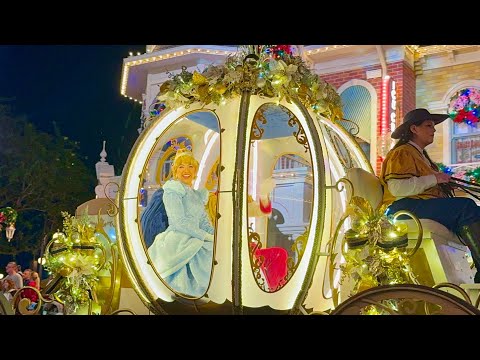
[0, 104, 96, 259]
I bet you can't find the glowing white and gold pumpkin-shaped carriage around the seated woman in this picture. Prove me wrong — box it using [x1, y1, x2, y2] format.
[116, 45, 475, 314]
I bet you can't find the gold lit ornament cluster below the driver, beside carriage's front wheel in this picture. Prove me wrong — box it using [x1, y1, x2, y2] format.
[340, 196, 416, 295]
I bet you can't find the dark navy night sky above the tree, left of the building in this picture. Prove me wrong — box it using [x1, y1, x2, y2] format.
[0, 45, 145, 175]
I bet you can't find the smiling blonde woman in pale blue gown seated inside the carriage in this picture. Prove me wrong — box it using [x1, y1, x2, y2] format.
[148, 151, 214, 297]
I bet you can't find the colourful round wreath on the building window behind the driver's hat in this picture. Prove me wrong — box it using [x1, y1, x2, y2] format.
[448, 88, 480, 125]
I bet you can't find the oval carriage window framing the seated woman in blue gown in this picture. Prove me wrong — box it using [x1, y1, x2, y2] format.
[138, 111, 220, 298]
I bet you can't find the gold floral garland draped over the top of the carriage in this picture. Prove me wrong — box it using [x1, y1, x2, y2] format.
[156, 45, 342, 121]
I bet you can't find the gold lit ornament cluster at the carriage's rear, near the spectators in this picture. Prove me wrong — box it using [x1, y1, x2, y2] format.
[45, 212, 106, 313]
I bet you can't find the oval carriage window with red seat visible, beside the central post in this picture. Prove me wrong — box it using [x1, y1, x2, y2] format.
[247, 104, 313, 292]
